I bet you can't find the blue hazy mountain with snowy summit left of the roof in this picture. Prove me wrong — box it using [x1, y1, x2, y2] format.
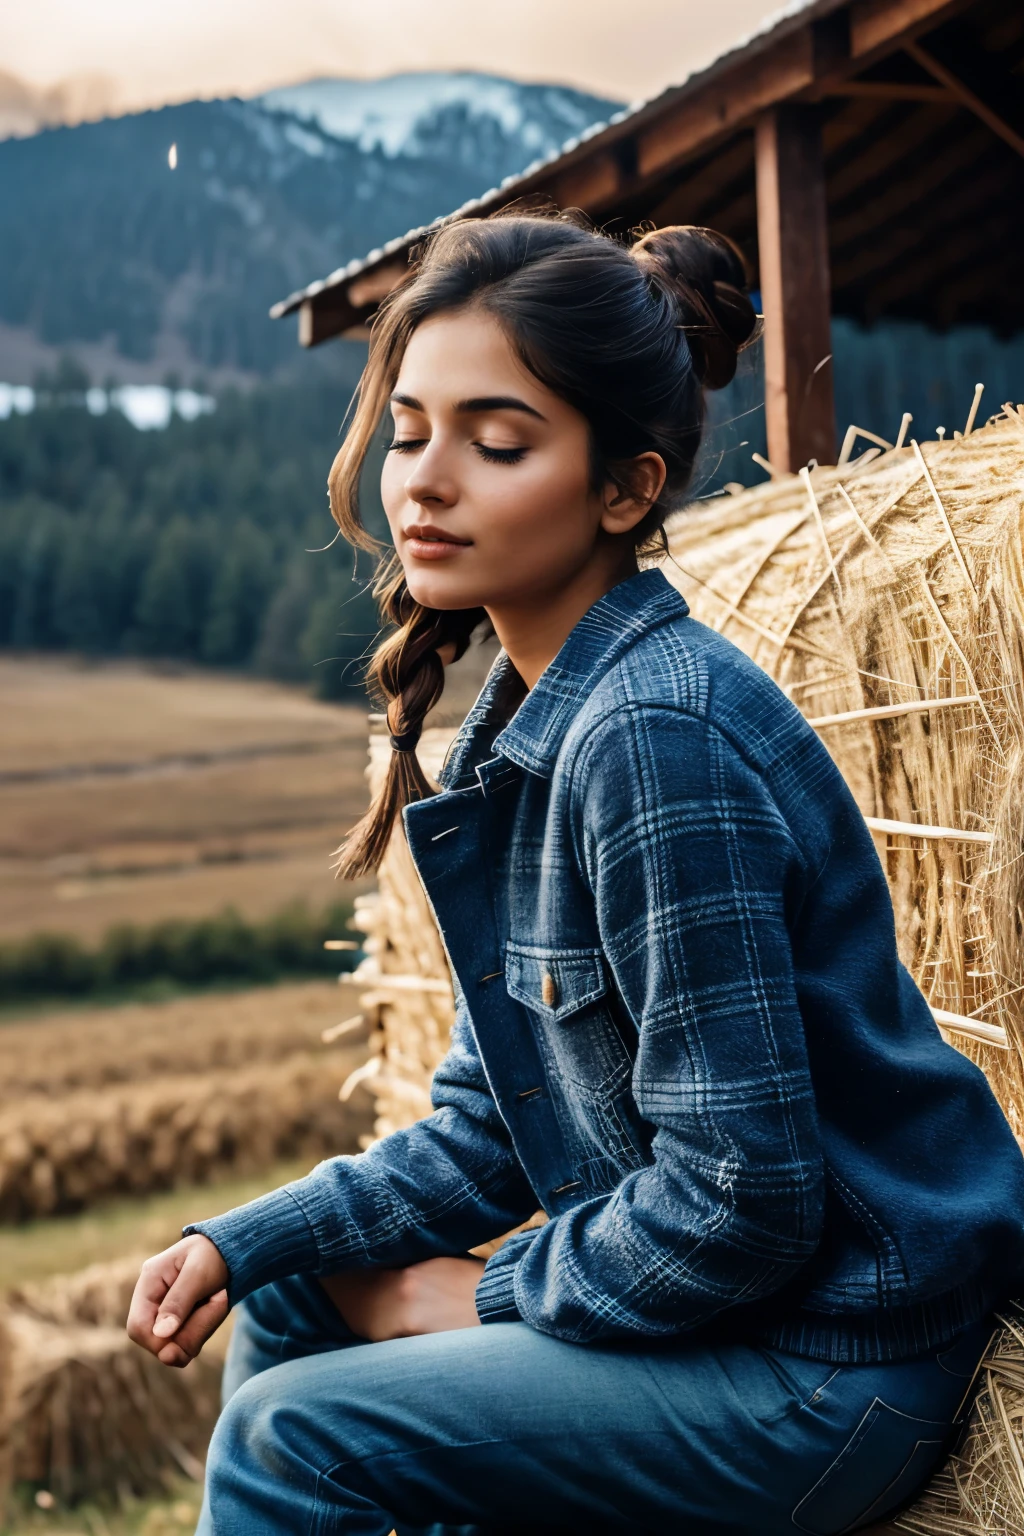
[0, 74, 617, 382]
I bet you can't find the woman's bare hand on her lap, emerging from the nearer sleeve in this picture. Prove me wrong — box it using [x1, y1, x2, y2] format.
[321, 1258, 484, 1344]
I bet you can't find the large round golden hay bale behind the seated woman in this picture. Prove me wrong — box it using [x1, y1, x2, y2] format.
[348, 406, 1024, 1536]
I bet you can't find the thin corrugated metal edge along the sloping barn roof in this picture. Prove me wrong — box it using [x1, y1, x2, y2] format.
[270, 0, 846, 319]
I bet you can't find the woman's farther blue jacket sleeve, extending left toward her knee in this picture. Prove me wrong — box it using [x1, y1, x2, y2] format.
[184, 1000, 537, 1304]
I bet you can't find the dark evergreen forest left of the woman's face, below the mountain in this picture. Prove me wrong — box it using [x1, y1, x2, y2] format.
[0, 353, 379, 697]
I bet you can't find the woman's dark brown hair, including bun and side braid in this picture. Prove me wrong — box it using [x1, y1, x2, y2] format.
[329, 212, 755, 876]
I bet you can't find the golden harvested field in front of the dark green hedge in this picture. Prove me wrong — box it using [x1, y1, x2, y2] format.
[0, 982, 372, 1511]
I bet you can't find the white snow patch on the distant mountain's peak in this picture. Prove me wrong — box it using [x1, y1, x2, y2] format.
[255, 71, 620, 158]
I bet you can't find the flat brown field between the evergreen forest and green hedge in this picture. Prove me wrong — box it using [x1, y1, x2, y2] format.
[0, 657, 374, 942]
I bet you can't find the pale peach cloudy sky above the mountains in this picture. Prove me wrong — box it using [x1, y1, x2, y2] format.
[0, 0, 780, 115]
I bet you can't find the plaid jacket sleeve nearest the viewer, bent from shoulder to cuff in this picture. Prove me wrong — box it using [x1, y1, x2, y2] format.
[477, 705, 824, 1341]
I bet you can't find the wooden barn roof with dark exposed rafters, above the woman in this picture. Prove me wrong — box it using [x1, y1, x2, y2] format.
[272, 0, 1024, 346]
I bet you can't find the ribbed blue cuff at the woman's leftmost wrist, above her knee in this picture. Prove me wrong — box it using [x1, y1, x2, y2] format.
[183, 1187, 319, 1307]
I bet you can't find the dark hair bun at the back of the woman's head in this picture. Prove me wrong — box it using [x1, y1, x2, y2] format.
[631, 224, 757, 389]
